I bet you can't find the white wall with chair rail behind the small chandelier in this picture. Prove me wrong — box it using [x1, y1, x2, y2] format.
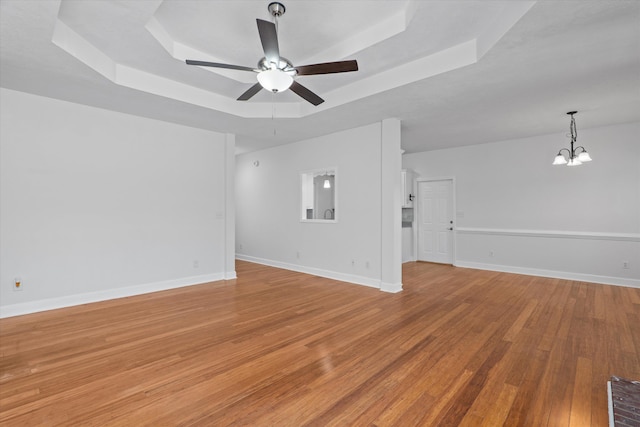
[403, 123, 640, 286]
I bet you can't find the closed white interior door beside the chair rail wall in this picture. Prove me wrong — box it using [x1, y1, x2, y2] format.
[418, 179, 453, 264]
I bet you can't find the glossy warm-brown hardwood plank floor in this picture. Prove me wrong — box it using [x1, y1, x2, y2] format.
[0, 262, 640, 427]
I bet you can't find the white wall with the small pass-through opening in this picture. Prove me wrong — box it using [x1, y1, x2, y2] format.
[236, 119, 401, 292]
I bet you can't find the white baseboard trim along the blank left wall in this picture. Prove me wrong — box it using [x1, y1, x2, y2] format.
[0, 272, 226, 319]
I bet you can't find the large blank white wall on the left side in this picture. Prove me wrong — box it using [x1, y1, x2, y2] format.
[0, 89, 235, 317]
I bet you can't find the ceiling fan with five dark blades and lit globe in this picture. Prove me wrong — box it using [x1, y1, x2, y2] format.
[185, 2, 358, 106]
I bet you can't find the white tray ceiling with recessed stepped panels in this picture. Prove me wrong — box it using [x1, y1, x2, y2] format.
[0, 0, 640, 152]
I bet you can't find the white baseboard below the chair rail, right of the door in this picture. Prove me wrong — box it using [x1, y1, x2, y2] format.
[455, 260, 640, 288]
